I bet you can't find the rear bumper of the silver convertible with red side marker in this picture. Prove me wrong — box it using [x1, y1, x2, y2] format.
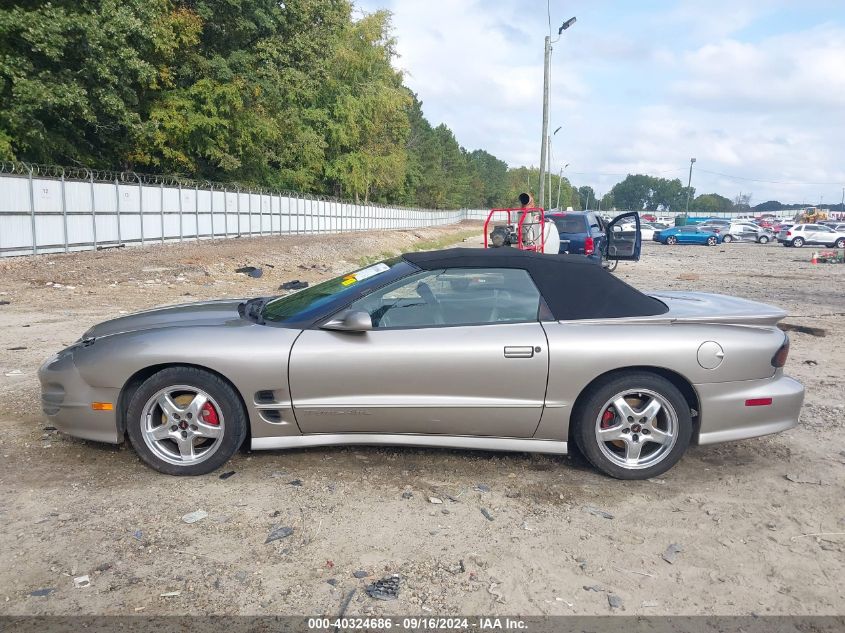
[694, 370, 804, 444]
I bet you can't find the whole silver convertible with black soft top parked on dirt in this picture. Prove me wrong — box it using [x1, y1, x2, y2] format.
[39, 249, 804, 479]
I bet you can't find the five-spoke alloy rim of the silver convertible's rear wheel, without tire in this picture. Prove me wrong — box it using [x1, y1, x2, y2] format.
[595, 389, 678, 470]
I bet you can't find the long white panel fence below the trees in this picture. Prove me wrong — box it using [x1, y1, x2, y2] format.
[0, 163, 487, 256]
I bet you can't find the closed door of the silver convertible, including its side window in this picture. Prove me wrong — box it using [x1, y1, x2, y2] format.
[289, 268, 548, 437]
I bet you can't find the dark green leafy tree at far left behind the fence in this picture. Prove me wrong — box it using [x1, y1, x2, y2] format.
[0, 0, 176, 168]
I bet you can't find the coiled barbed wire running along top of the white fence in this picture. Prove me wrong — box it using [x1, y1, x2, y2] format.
[0, 161, 468, 215]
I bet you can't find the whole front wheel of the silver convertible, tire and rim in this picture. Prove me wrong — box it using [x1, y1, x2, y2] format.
[126, 367, 247, 475]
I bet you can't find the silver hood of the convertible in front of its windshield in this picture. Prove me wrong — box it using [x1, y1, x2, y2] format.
[82, 299, 245, 339]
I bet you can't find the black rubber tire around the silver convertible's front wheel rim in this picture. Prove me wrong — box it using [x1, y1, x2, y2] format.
[126, 367, 248, 475]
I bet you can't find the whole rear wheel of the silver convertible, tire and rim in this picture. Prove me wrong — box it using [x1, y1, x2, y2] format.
[573, 371, 692, 479]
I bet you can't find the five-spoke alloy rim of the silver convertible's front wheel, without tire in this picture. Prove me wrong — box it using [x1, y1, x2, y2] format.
[140, 385, 225, 466]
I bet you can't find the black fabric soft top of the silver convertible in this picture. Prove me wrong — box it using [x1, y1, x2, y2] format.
[402, 248, 668, 321]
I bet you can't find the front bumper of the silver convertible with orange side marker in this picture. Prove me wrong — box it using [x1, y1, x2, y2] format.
[38, 350, 122, 444]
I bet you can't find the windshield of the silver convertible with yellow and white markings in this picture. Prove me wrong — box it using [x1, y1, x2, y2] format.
[261, 257, 415, 323]
